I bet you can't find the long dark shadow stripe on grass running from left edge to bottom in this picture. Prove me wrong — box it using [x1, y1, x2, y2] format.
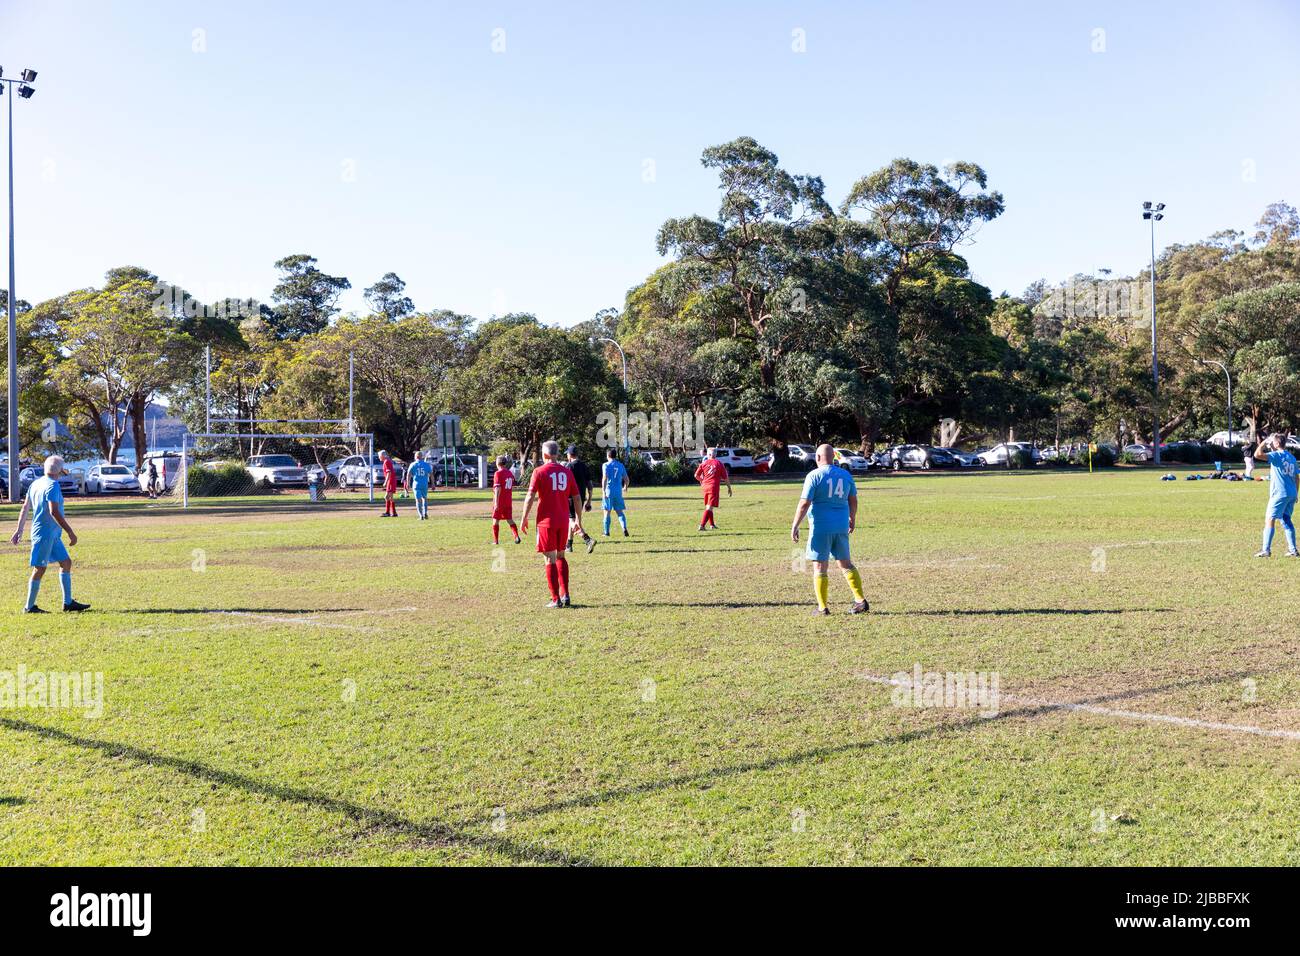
[0, 717, 597, 866]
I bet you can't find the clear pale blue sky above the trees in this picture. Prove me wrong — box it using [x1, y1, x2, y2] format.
[0, 0, 1300, 324]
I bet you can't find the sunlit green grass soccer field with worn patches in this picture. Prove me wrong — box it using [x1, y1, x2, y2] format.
[0, 470, 1300, 865]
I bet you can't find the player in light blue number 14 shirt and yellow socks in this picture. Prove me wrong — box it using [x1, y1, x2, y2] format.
[790, 445, 871, 614]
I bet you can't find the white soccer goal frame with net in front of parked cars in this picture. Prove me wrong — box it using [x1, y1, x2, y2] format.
[178, 431, 374, 509]
